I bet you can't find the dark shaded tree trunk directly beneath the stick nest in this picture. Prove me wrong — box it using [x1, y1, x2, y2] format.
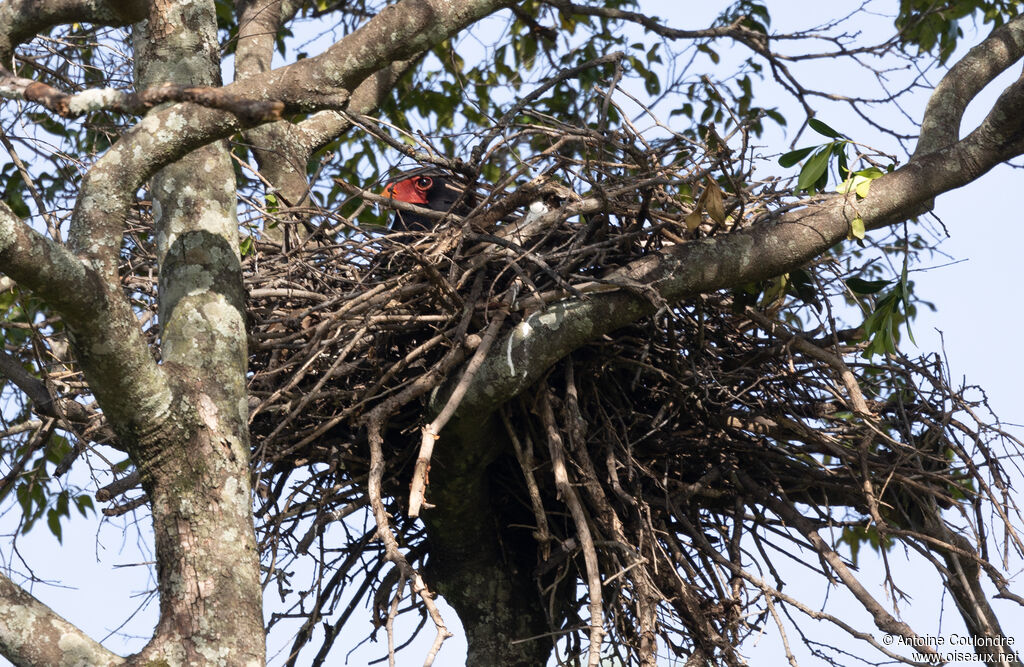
[423, 424, 552, 667]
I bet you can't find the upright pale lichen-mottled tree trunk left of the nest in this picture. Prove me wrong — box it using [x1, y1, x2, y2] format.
[134, 0, 264, 665]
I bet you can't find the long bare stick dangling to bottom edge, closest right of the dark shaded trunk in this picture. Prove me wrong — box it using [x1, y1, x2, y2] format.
[538, 387, 604, 667]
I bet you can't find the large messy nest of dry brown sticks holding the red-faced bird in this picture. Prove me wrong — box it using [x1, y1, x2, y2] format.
[228, 156, 1021, 664]
